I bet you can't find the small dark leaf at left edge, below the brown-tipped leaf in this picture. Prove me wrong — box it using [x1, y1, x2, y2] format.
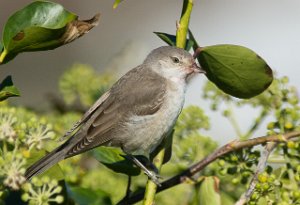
[0, 76, 20, 101]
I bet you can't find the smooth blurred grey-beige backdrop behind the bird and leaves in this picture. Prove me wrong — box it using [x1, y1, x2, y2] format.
[0, 0, 300, 143]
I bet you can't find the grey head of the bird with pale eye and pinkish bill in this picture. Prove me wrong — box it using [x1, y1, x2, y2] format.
[144, 46, 204, 79]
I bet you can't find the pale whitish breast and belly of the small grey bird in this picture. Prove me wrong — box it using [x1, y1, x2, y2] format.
[123, 79, 186, 156]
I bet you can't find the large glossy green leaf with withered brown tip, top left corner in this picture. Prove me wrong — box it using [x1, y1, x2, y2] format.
[0, 1, 99, 64]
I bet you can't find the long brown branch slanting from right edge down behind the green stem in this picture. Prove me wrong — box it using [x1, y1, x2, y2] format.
[118, 131, 300, 205]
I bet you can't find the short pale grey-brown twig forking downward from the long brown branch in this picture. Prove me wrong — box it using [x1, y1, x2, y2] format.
[235, 142, 278, 205]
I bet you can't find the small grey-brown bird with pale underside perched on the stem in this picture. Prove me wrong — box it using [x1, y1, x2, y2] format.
[25, 46, 204, 184]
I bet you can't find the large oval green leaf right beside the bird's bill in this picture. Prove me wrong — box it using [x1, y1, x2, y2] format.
[198, 44, 273, 98]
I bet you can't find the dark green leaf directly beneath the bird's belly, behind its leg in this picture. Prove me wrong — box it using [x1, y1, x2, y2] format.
[92, 146, 140, 176]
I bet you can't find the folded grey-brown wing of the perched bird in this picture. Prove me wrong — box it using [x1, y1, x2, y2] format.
[67, 68, 166, 157]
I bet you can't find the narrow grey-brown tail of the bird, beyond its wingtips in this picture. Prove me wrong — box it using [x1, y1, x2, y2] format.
[25, 145, 65, 180]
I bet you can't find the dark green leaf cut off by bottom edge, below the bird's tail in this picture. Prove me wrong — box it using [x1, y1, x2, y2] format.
[67, 184, 112, 205]
